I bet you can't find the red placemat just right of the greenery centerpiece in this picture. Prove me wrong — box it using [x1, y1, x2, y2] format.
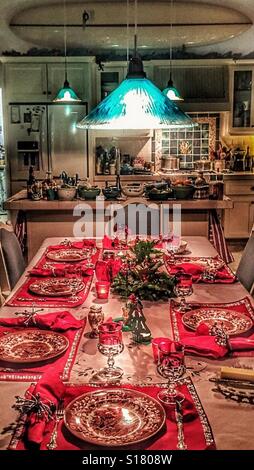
[165, 256, 236, 284]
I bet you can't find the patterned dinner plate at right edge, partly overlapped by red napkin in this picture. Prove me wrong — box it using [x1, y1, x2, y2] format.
[182, 308, 253, 336]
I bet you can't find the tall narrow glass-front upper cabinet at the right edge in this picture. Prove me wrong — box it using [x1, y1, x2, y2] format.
[230, 66, 254, 134]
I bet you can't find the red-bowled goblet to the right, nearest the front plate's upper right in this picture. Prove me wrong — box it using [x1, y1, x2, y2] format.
[157, 341, 186, 405]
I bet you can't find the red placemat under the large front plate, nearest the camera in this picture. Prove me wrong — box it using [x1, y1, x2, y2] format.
[9, 378, 215, 451]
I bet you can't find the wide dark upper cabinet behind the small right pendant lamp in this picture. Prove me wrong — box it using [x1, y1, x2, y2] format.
[154, 65, 230, 112]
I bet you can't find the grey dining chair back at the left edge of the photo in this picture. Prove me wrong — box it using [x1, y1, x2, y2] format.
[0, 226, 26, 290]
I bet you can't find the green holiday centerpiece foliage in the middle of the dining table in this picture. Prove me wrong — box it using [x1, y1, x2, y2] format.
[111, 240, 176, 301]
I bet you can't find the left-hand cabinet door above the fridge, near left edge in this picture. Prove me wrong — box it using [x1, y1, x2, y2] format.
[5, 63, 47, 102]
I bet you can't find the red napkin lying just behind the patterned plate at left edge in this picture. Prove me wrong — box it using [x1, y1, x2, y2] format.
[0, 312, 86, 331]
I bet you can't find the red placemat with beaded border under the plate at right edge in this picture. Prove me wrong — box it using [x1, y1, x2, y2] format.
[170, 297, 254, 359]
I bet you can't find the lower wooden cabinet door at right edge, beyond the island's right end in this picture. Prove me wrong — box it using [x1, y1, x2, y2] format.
[224, 200, 254, 238]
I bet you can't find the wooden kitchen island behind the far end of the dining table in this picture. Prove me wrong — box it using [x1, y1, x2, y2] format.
[4, 190, 233, 261]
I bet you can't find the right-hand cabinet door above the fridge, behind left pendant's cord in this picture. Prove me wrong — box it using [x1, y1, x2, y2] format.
[48, 63, 91, 102]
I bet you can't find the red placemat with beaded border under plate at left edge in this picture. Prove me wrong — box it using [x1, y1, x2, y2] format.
[0, 322, 86, 382]
